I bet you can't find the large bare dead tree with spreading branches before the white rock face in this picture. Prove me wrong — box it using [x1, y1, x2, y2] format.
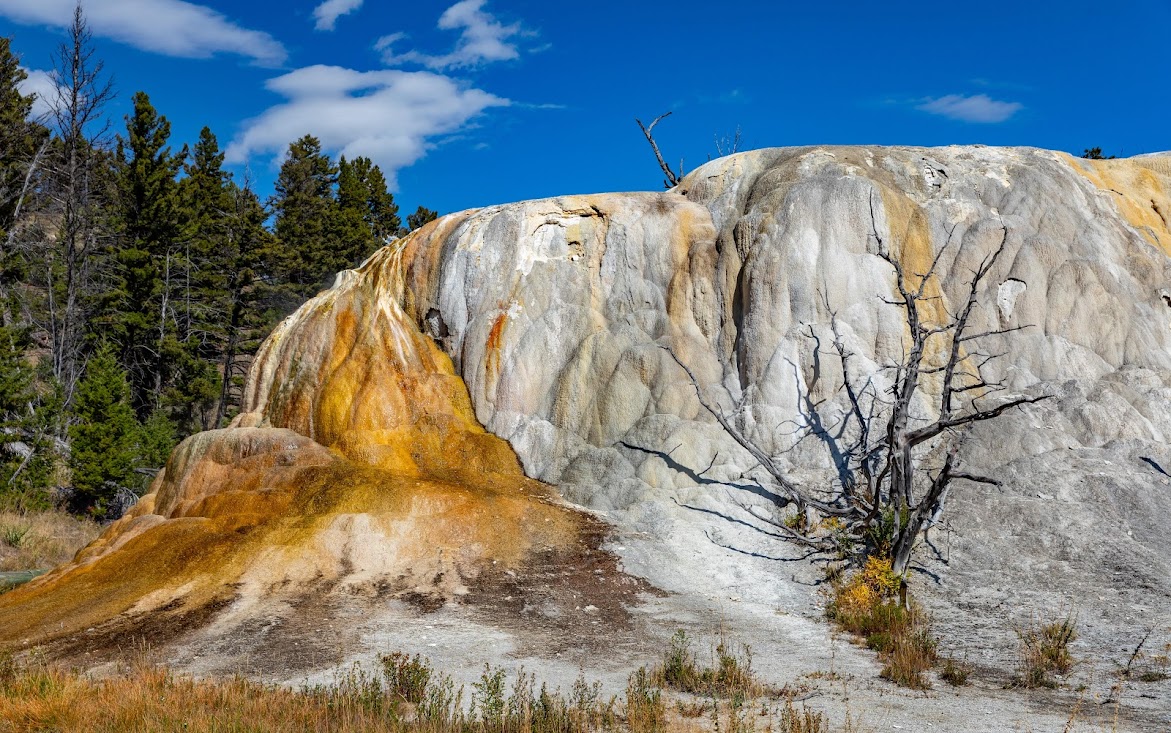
[669, 193, 1049, 575]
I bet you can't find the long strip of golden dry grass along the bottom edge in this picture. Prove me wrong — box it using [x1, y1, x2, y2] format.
[0, 653, 857, 733]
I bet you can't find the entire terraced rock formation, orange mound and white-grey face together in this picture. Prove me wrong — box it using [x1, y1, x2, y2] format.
[0, 146, 1171, 725]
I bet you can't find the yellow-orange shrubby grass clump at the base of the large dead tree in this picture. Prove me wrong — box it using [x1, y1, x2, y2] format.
[826, 557, 938, 690]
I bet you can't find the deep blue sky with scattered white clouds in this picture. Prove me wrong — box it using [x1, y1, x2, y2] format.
[0, 0, 1171, 213]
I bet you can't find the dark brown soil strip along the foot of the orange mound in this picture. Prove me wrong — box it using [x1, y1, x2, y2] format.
[11, 508, 663, 679]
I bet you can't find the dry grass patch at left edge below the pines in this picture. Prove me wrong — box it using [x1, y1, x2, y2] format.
[0, 511, 101, 571]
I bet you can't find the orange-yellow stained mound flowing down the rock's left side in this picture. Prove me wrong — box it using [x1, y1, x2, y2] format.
[0, 230, 583, 646]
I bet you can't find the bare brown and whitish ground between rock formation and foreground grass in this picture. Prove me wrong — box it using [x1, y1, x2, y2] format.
[4, 501, 1171, 733]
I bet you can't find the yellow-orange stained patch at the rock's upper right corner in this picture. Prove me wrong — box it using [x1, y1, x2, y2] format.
[1061, 153, 1171, 254]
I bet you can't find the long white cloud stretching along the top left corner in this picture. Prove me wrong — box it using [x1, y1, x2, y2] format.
[0, 0, 288, 66]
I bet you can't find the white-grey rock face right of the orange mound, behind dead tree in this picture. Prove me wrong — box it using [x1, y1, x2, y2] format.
[377, 146, 1171, 660]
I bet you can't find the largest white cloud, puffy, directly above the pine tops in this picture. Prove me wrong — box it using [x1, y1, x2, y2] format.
[227, 66, 509, 186]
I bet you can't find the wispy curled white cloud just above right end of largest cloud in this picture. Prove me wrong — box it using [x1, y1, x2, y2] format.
[375, 0, 525, 69]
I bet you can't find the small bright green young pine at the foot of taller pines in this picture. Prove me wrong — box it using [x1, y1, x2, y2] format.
[69, 342, 142, 519]
